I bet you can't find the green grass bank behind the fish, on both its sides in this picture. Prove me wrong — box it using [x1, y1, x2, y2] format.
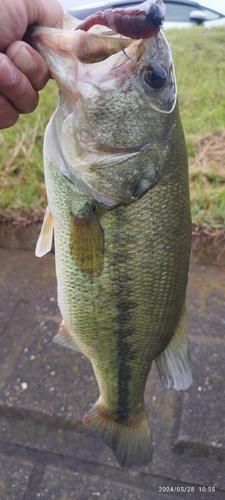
[0, 27, 225, 236]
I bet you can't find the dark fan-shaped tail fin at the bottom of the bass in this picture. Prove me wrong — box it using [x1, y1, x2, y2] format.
[83, 399, 152, 467]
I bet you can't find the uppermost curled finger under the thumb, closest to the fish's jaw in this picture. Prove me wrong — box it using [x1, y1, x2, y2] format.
[6, 41, 49, 90]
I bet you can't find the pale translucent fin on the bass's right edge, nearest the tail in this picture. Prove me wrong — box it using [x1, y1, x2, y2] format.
[155, 305, 192, 391]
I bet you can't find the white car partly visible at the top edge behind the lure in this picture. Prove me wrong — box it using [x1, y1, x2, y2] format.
[60, 0, 225, 29]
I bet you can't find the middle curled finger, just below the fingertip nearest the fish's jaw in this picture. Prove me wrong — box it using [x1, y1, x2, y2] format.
[0, 54, 39, 113]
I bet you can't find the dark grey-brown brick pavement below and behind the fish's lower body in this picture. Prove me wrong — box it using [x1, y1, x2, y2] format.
[0, 248, 225, 500]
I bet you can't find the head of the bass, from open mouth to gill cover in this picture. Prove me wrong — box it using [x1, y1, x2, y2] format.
[32, 16, 177, 206]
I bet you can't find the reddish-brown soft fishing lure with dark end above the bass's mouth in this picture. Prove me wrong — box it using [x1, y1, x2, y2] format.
[76, 0, 165, 40]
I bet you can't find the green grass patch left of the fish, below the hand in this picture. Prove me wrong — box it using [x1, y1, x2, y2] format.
[0, 81, 58, 216]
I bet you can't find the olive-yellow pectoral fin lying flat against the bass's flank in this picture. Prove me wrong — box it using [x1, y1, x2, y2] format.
[70, 204, 104, 276]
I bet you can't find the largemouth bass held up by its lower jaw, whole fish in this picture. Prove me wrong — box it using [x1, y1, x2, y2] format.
[33, 13, 192, 467]
